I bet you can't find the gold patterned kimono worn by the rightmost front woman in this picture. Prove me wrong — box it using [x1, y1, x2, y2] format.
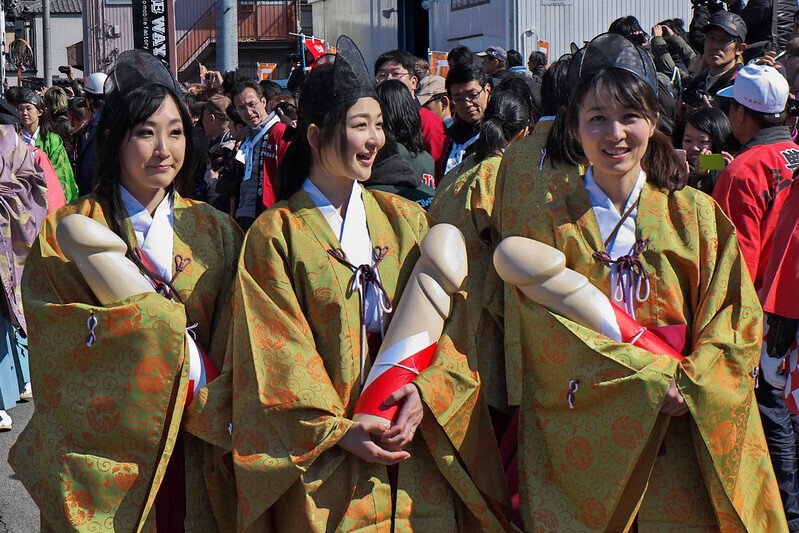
[497, 154, 787, 532]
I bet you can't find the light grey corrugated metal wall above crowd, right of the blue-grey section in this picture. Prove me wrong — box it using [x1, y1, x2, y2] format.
[520, 0, 692, 58]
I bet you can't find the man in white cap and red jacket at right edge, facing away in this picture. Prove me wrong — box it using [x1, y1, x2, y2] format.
[713, 64, 799, 531]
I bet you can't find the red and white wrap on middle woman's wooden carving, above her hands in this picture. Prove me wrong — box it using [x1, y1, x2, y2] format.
[355, 331, 438, 422]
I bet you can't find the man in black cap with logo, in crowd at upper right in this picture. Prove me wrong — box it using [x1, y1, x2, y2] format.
[683, 11, 746, 113]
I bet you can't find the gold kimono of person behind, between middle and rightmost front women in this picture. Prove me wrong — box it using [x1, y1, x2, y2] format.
[428, 156, 509, 413]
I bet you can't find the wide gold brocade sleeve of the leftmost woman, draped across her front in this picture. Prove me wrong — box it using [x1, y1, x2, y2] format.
[9, 217, 188, 531]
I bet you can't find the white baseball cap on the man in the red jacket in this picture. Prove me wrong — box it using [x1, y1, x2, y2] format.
[717, 65, 789, 115]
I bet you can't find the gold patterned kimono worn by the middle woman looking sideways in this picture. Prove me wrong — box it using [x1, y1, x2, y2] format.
[191, 185, 506, 532]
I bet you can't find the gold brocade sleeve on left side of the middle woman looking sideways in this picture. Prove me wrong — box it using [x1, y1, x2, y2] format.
[230, 216, 352, 529]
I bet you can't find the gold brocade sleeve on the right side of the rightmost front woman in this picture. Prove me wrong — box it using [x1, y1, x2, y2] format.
[677, 200, 785, 531]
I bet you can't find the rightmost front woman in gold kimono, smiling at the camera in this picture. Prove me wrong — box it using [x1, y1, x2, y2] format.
[504, 34, 787, 531]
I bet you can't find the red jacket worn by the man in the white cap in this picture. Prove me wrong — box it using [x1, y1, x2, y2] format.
[713, 126, 799, 290]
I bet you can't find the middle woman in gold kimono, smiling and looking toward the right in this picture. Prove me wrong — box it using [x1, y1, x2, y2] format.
[196, 37, 504, 532]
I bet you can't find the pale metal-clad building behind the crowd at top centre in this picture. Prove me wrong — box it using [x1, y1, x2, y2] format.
[309, 0, 692, 71]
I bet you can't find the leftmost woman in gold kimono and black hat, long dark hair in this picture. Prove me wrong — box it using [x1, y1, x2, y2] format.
[9, 51, 242, 532]
